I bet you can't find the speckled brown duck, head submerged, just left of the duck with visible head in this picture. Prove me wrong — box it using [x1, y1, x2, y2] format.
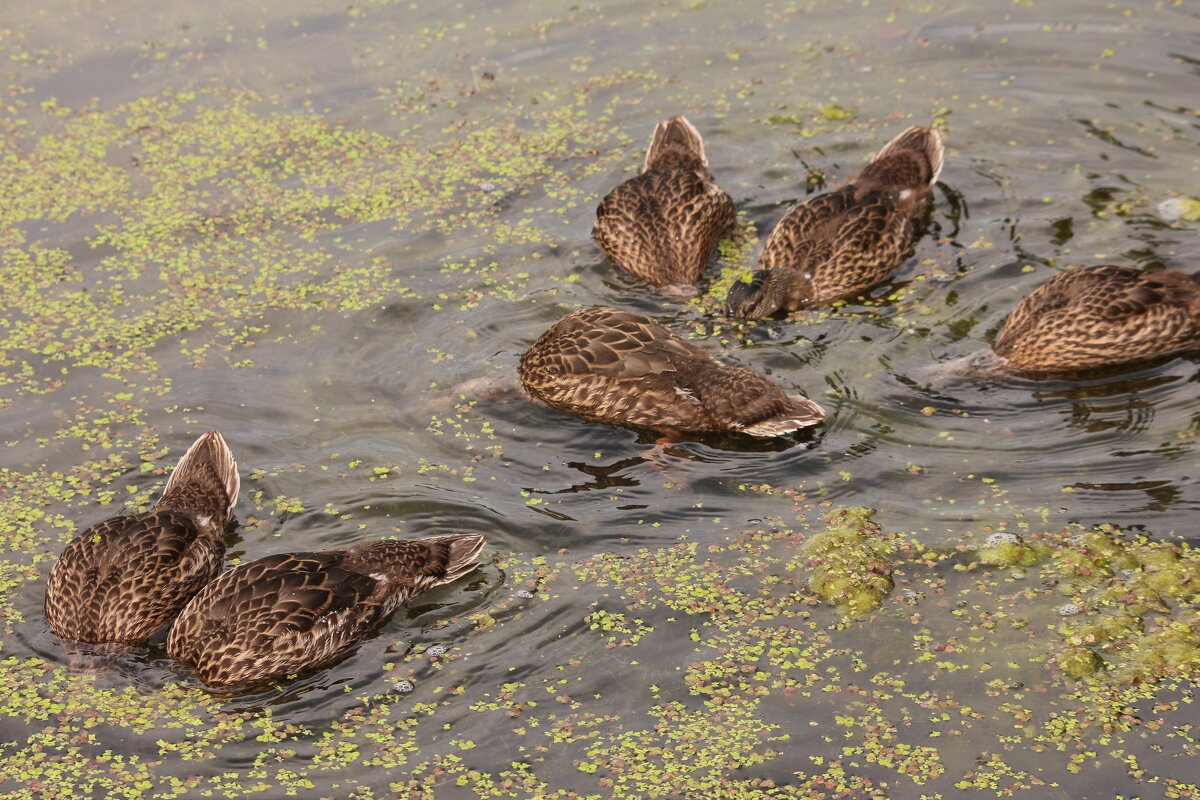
[592, 115, 734, 295]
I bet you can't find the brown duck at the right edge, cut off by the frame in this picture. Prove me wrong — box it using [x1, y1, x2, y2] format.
[941, 265, 1200, 377]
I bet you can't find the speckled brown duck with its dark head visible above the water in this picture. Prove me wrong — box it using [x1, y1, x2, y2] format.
[726, 126, 944, 319]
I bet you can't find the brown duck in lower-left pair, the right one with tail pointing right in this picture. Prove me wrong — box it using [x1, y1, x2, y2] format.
[167, 534, 485, 693]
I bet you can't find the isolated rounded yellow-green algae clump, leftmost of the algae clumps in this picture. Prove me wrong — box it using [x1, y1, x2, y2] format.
[793, 507, 895, 619]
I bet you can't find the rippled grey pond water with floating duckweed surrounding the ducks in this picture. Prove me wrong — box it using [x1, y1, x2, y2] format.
[0, 0, 1200, 799]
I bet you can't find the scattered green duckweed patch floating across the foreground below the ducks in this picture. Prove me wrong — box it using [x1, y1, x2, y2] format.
[7, 501, 1200, 800]
